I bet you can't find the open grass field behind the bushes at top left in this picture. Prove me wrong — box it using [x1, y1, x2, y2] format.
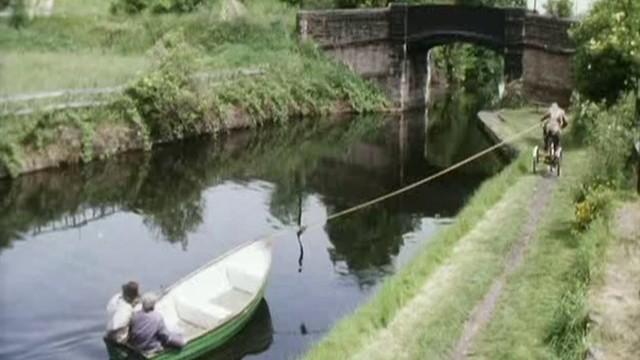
[0, 0, 304, 94]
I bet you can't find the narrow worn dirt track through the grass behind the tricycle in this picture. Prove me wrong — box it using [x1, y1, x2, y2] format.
[452, 177, 555, 360]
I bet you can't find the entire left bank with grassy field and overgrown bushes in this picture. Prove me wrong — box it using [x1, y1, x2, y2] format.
[0, 0, 387, 176]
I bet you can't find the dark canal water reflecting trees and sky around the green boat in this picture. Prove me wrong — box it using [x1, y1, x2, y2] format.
[0, 93, 501, 360]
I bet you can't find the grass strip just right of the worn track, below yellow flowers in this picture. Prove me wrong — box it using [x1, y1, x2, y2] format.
[473, 150, 586, 359]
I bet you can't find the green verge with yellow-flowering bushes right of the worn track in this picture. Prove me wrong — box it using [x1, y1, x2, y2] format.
[472, 96, 637, 359]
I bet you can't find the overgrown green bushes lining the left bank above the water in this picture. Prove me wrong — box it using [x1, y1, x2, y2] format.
[0, 23, 387, 176]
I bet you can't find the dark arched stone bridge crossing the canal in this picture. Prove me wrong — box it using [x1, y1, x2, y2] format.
[297, 3, 575, 110]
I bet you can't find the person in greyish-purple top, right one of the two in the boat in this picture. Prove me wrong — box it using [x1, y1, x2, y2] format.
[129, 293, 185, 353]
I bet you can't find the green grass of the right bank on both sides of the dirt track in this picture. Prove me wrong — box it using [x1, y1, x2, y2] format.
[307, 102, 626, 359]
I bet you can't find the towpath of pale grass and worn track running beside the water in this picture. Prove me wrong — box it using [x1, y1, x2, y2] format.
[353, 113, 556, 360]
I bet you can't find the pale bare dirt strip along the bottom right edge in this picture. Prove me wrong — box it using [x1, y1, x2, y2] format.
[588, 201, 640, 360]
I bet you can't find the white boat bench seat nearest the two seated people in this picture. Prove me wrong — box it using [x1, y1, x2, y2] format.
[174, 296, 231, 329]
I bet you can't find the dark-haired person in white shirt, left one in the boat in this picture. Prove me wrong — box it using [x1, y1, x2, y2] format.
[107, 281, 139, 344]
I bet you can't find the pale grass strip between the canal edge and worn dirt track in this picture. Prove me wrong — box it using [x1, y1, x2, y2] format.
[355, 176, 537, 359]
